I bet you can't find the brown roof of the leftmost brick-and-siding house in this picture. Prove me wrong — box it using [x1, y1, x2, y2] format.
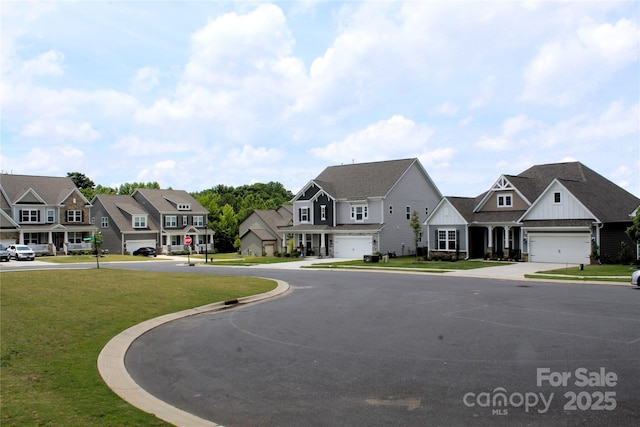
[0, 174, 89, 205]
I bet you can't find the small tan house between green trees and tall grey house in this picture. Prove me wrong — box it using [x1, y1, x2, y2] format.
[238, 205, 293, 256]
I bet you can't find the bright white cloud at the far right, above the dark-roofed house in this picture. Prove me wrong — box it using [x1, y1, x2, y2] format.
[522, 19, 640, 106]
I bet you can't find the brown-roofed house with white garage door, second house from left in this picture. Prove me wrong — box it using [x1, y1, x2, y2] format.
[91, 194, 160, 254]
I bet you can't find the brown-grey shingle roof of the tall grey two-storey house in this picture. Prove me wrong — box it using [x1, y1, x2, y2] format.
[313, 159, 417, 200]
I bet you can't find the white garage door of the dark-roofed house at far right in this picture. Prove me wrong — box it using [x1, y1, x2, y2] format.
[529, 233, 591, 264]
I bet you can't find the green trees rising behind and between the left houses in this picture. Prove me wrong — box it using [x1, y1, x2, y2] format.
[67, 172, 293, 252]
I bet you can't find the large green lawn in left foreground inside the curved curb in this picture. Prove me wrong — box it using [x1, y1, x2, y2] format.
[0, 269, 276, 426]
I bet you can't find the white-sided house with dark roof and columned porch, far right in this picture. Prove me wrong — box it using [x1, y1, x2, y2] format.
[425, 162, 640, 264]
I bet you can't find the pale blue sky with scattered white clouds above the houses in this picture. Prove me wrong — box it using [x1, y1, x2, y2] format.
[0, 0, 640, 196]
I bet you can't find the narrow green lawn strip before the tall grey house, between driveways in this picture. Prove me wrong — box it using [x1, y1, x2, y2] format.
[311, 256, 511, 272]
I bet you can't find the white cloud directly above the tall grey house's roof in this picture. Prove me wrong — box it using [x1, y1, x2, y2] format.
[310, 115, 433, 163]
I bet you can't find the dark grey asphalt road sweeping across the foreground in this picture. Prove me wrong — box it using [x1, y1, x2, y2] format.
[118, 263, 640, 426]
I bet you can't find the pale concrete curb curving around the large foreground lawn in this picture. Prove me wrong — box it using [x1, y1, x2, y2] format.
[97, 279, 289, 427]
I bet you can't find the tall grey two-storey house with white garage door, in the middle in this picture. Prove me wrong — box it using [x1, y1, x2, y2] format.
[279, 159, 441, 258]
